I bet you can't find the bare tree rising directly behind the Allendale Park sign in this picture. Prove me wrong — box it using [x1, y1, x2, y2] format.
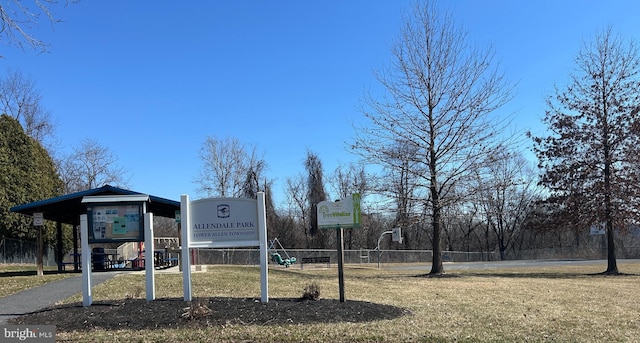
[195, 137, 266, 197]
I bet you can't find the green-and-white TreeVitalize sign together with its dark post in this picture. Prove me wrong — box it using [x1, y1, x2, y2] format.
[317, 193, 362, 302]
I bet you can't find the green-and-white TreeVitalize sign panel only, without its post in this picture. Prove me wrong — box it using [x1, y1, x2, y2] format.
[318, 193, 362, 229]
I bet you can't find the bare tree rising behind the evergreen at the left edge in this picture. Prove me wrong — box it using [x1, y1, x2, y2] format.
[0, 69, 55, 146]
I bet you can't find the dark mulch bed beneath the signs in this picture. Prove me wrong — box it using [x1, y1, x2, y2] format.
[10, 298, 409, 332]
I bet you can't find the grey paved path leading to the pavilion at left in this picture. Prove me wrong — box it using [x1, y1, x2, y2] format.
[0, 271, 124, 325]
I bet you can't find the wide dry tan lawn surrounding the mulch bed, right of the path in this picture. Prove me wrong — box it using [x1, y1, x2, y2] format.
[5, 263, 640, 342]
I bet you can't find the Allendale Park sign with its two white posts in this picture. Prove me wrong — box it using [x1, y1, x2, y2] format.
[180, 192, 269, 303]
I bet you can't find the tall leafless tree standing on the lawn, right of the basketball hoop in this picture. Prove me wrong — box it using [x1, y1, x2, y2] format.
[354, 2, 512, 274]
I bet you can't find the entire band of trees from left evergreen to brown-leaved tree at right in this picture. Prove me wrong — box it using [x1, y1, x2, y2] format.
[0, 2, 640, 274]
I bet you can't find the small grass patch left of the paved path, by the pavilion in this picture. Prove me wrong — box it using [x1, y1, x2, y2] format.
[0, 264, 77, 297]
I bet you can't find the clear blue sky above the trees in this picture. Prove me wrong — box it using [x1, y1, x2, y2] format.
[0, 0, 640, 203]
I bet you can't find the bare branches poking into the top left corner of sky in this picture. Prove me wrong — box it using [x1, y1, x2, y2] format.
[0, 0, 77, 52]
